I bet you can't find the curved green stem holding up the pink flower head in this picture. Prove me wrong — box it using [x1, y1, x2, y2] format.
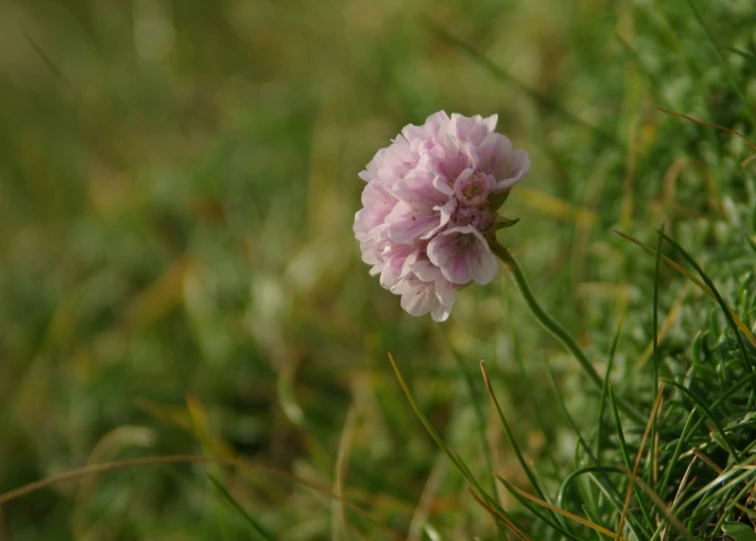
[489, 240, 646, 424]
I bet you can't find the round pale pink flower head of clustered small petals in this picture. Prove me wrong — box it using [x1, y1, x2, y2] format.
[354, 111, 530, 321]
